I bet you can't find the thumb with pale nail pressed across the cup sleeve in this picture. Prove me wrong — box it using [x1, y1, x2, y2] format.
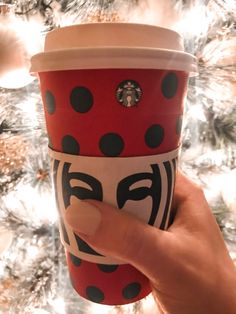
[65, 200, 168, 278]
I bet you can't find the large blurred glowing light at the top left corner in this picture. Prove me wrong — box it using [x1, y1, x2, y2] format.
[0, 3, 42, 89]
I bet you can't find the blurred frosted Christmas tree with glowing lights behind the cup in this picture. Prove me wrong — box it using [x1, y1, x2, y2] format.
[0, 0, 236, 314]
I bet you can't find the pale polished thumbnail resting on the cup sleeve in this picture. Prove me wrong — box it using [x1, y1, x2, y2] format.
[65, 201, 102, 235]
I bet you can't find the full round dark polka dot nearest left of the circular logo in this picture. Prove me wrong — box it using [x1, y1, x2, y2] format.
[70, 87, 93, 113]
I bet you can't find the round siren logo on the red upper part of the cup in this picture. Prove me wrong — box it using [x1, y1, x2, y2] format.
[116, 80, 142, 107]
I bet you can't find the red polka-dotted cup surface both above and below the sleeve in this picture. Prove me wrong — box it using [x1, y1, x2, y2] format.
[39, 69, 187, 305]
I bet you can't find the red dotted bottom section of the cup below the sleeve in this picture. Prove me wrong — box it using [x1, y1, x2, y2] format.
[66, 251, 148, 305]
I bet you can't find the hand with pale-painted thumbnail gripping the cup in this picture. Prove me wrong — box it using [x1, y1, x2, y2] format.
[66, 173, 236, 314]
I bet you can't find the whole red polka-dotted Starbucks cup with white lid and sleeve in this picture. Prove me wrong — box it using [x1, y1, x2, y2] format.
[31, 23, 197, 305]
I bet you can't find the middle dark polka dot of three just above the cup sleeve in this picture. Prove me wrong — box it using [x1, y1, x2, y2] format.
[99, 133, 124, 157]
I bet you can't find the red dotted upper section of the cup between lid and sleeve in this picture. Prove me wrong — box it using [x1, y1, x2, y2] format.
[40, 69, 187, 157]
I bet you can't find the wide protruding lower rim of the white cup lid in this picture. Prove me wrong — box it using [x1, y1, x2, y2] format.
[30, 46, 197, 76]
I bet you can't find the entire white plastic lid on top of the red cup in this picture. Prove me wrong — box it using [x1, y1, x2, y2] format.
[31, 23, 197, 73]
